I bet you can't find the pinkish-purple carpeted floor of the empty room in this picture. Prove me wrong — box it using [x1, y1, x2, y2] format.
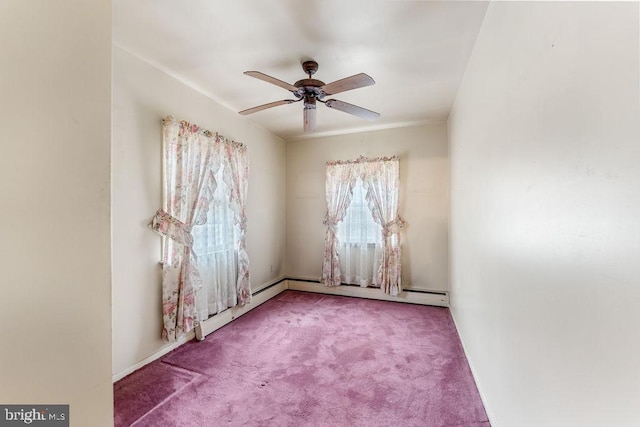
[114, 291, 489, 427]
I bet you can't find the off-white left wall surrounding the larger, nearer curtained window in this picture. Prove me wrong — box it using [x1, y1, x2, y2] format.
[112, 47, 285, 375]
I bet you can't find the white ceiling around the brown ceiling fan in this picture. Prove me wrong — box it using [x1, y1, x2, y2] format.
[113, 0, 488, 139]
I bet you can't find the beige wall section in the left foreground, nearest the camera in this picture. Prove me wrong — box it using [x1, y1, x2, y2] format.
[0, 0, 113, 426]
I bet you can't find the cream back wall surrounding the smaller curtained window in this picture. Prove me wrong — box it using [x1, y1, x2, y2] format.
[286, 123, 449, 291]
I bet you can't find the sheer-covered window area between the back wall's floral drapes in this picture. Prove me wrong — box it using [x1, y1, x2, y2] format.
[338, 178, 382, 286]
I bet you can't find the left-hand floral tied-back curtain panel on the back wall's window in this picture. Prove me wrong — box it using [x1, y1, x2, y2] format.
[322, 163, 358, 286]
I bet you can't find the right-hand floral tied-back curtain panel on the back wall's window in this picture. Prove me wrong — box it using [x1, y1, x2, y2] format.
[362, 157, 405, 295]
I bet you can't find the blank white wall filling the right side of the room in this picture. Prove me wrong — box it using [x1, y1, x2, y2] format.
[449, 2, 640, 427]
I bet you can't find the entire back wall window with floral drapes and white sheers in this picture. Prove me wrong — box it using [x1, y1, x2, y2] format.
[322, 156, 406, 295]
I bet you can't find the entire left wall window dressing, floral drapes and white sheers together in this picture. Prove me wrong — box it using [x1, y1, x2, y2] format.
[150, 116, 250, 341]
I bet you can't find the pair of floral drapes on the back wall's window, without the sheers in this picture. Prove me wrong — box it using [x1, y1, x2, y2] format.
[322, 156, 406, 295]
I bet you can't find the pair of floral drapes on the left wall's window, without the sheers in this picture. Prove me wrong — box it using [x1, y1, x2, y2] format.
[150, 116, 250, 341]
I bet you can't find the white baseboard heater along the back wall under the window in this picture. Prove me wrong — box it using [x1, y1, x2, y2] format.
[287, 279, 449, 307]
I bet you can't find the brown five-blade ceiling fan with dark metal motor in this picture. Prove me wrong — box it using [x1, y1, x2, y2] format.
[239, 61, 380, 132]
